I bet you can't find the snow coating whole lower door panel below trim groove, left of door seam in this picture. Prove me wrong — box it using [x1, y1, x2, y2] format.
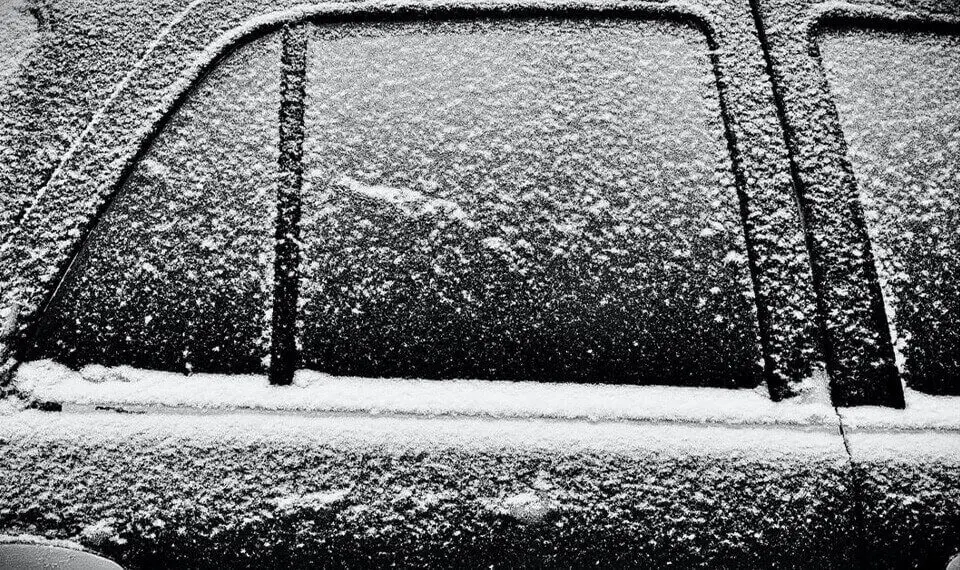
[0, 402, 849, 567]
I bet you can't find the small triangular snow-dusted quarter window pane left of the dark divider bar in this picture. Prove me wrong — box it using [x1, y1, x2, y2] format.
[34, 38, 280, 371]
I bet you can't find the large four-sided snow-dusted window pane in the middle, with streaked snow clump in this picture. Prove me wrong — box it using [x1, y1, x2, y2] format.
[300, 20, 760, 386]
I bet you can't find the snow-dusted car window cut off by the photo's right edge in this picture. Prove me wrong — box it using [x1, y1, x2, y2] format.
[819, 29, 960, 393]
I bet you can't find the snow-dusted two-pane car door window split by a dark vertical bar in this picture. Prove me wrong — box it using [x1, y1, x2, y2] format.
[35, 18, 761, 387]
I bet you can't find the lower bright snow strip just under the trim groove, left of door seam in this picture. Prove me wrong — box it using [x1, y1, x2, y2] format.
[0, 409, 848, 454]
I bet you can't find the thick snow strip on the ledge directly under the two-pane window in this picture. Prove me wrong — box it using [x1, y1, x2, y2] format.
[12, 361, 837, 426]
